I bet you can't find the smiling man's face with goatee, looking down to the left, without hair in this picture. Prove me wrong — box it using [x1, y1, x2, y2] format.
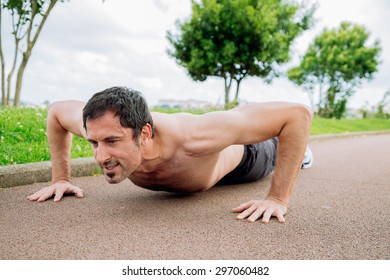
[86, 111, 141, 184]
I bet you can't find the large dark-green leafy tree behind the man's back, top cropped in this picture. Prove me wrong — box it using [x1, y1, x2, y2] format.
[167, 0, 315, 107]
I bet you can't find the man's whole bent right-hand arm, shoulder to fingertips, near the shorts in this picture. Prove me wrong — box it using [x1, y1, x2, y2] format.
[187, 102, 312, 223]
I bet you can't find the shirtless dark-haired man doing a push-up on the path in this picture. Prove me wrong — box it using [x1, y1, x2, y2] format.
[28, 87, 312, 223]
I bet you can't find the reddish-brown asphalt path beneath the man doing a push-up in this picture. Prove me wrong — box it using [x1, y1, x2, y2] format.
[0, 134, 390, 260]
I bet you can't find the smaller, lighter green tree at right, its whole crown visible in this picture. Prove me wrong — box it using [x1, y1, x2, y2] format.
[288, 22, 381, 119]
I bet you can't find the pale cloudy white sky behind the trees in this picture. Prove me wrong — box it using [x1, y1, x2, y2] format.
[3, 0, 390, 109]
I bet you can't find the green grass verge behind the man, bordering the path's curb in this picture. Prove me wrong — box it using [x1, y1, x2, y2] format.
[0, 108, 390, 165]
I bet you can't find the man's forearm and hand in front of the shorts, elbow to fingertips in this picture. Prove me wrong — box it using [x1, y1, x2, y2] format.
[233, 103, 312, 223]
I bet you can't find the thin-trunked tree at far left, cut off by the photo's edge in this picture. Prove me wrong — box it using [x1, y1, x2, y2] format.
[0, 0, 64, 107]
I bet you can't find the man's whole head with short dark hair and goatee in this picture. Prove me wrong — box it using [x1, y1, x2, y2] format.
[83, 87, 153, 183]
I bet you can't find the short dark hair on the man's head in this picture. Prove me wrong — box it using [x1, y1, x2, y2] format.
[83, 87, 154, 139]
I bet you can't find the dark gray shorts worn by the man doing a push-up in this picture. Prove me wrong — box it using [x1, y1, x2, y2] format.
[218, 137, 278, 185]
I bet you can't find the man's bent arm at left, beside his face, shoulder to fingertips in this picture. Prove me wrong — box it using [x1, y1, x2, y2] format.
[28, 101, 85, 202]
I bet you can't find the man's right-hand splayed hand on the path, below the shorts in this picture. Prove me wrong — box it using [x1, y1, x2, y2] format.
[232, 198, 287, 224]
